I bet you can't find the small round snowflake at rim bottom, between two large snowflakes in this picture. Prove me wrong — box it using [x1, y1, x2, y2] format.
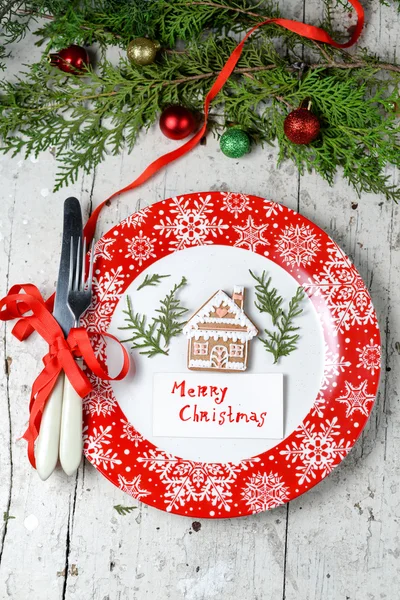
[241, 473, 289, 513]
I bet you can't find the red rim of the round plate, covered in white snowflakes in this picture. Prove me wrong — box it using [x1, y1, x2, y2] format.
[84, 192, 380, 518]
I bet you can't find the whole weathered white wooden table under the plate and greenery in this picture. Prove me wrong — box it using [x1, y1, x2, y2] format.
[0, 0, 400, 600]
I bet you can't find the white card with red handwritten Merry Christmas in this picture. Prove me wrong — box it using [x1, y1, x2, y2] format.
[153, 372, 283, 439]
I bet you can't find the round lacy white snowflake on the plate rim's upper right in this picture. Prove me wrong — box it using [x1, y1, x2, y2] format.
[276, 225, 321, 267]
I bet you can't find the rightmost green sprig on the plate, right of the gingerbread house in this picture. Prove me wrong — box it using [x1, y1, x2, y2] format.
[260, 288, 304, 364]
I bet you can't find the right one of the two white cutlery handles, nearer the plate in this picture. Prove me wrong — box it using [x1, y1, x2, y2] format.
[60, 368, 83, 475]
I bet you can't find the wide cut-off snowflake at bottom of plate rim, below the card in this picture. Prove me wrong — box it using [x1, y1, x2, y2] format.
[137, 450, 260, 512]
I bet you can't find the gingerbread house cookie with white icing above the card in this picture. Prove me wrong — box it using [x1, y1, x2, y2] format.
[183, 286, 258, 372]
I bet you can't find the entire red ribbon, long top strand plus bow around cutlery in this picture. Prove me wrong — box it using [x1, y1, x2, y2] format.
[0, 0, 364, 466]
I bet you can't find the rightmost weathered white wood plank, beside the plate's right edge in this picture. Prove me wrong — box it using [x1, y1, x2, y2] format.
[285, 2, 400, 600]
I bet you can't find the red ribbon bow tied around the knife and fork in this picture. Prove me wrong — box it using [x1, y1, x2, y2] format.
[0, 284, 129, 468]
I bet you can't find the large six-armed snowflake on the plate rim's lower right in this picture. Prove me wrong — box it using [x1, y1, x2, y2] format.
[280, 417, 351, 485]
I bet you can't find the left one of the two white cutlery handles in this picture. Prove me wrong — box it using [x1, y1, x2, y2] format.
[35, 373, 64, 481]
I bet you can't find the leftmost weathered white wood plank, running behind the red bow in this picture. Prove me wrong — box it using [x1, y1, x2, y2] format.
[0, 29, 97, 600]
